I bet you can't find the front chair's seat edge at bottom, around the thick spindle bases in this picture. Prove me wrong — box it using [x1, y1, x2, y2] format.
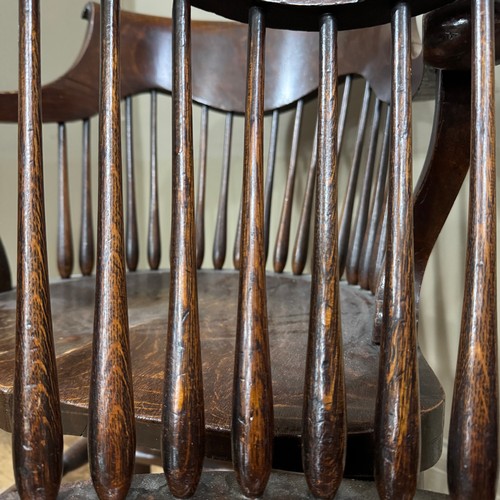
[5, 471, 448, 500]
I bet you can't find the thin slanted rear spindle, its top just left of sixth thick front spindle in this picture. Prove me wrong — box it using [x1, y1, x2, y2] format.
[359, 108, 391, 289]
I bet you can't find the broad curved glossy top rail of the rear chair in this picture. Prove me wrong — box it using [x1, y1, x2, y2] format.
[0, 3, 423, 122]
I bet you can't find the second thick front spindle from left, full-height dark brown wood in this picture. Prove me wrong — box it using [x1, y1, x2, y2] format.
[88, 0, 135, 499]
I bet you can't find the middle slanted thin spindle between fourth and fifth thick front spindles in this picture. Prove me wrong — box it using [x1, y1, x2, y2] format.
[274, 99, 304, 273]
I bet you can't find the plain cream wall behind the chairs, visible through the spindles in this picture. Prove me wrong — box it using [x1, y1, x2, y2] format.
[0, 0, 500, 490]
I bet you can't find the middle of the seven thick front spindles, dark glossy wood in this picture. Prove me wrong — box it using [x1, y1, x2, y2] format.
[232, 7, 273, 497]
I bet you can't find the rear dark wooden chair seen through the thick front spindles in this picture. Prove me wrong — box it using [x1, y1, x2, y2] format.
[0, 0, 444, 477]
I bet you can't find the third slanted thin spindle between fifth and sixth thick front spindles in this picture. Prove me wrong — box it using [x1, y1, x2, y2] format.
[346, 99, 382, 285]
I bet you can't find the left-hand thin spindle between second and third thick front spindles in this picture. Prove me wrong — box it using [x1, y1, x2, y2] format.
[125, 96, 139, 271]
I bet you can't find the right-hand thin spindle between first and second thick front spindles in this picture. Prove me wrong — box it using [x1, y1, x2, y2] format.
[79, 118, 94, 276]
